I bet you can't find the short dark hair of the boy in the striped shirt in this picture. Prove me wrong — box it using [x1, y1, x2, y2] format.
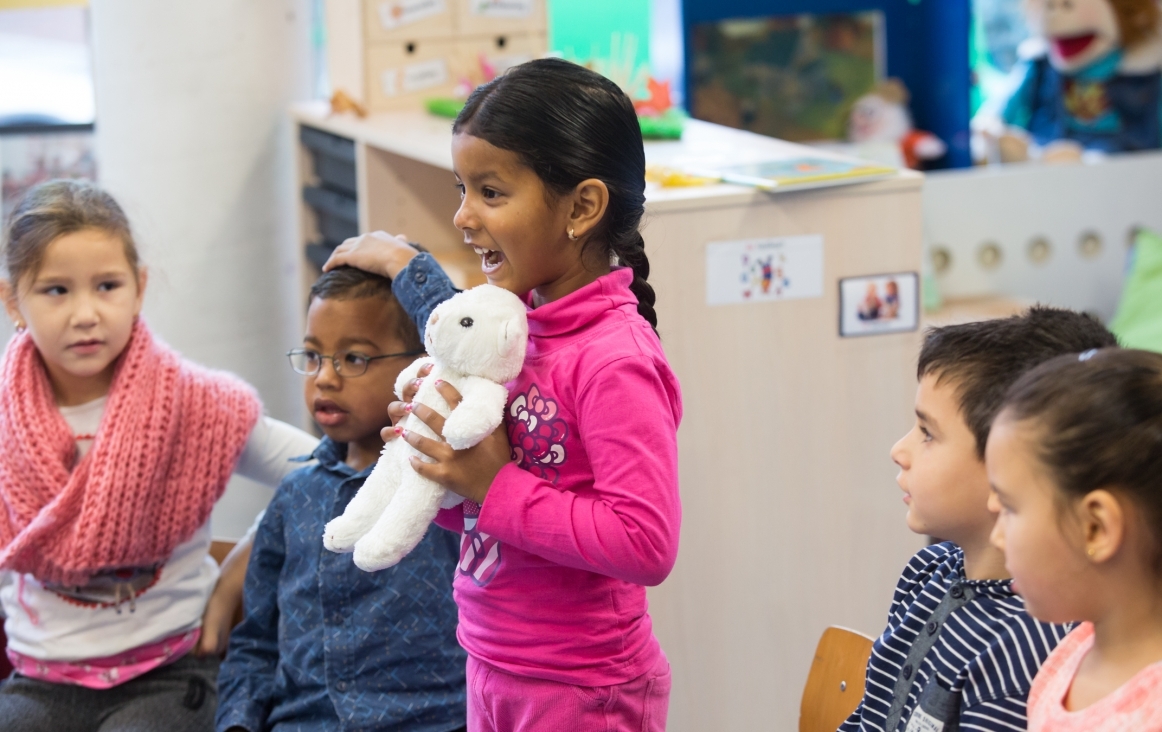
[917, 306, 1118, 460]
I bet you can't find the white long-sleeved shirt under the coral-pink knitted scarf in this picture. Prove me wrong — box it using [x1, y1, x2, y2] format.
[0, 397, 318, 661]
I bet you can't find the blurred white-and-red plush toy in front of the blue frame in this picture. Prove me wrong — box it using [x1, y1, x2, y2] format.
[847, 79, 948, 170]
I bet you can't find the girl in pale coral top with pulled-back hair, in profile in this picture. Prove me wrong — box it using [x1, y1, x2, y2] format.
[985, 349, 1162, 732]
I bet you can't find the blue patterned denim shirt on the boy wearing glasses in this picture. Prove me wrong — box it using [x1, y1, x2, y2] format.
[217, 438, 466, 732]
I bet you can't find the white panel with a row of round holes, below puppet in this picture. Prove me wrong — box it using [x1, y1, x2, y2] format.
[924, 151, 1162, 321]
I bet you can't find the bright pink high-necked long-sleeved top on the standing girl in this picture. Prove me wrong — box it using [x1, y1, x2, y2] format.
[437, 268, 682, 686]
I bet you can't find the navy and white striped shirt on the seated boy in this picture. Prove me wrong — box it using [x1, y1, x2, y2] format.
[839, 543, 1070, 732]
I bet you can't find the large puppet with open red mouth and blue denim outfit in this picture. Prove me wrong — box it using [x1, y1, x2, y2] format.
[990, 0, 1162, 162]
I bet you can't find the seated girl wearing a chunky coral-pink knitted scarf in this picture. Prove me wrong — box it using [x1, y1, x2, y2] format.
[0, 181, 315, 731]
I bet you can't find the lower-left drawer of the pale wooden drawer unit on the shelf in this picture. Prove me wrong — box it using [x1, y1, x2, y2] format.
[366, 38, 461, 112]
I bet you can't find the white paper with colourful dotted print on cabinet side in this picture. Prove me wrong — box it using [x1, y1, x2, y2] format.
[706, 234, 823, 306]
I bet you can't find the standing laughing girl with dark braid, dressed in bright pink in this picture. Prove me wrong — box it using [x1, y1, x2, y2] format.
[328, 59, 682, 732]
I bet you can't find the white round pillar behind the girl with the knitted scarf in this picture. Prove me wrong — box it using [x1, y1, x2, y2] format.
[92, 0, 311, 537]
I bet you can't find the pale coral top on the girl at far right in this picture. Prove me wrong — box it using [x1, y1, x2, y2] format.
[1028, 623, 1162, 732]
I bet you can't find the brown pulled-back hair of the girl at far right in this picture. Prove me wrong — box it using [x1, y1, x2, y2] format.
[1000, 349, 1162, 570]
